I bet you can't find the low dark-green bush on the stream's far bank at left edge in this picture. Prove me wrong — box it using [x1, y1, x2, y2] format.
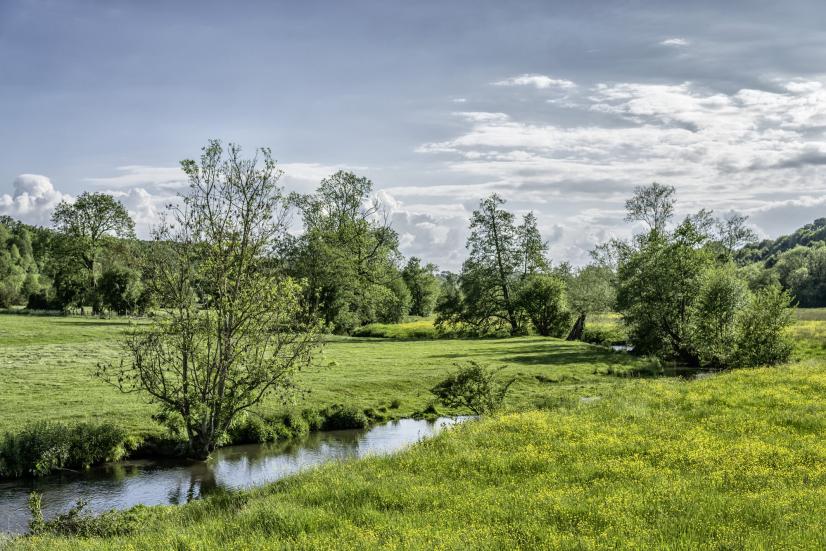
[0, 421, 131, 477]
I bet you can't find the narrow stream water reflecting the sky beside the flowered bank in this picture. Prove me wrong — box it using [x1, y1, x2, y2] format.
[0, 417, 468, 533]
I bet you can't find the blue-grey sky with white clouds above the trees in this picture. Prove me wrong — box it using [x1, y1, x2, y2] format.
[0, 0, 826, 270]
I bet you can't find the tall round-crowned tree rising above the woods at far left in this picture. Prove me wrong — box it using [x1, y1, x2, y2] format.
[52, 192, 135, 313]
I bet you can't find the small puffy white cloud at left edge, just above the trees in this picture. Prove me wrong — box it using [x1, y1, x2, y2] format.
[0, 174, 72, 226]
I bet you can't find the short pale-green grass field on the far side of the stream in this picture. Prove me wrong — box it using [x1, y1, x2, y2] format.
[0, 315, 641, 440]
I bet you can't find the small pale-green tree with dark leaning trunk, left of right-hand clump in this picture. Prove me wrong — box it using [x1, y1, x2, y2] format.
[567, 264, 617, 341]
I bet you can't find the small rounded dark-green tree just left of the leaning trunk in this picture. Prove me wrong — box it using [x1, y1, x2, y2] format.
[517, 274, 571, 337]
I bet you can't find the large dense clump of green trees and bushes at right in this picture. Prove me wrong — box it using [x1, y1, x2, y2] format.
[614, 185, 792, 368]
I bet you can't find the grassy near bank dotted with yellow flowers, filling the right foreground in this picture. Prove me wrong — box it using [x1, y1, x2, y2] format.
[14, 360, 826, 549]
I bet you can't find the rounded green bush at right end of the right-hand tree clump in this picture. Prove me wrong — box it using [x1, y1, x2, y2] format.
[736, 285, 792, 367]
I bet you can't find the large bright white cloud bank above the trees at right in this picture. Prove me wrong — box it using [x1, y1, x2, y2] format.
[418, 80, 826, 261]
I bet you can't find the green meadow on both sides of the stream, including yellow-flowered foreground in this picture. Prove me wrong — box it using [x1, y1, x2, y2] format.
[0, 312, 826, 549]
